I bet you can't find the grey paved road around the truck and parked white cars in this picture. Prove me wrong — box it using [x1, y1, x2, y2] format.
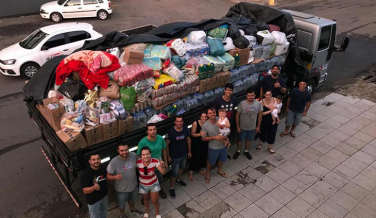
[0, 0, 376, 217]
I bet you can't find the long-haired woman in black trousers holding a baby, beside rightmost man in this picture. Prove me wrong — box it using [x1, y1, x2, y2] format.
[256, 90, 278, 155]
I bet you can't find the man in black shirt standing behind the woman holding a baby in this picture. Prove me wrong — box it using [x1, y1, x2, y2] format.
[260, 65, 287, 99]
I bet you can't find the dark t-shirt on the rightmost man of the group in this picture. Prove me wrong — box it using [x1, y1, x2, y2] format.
[289, 88, 311, 113]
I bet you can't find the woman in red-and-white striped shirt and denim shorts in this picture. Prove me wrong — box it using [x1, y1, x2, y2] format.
[137, 146, 166, 218]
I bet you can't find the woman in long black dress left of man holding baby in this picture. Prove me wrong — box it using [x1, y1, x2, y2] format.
[188, 112, 208, 181]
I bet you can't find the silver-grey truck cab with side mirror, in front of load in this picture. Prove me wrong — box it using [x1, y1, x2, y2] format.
[283, 10, 349, 92]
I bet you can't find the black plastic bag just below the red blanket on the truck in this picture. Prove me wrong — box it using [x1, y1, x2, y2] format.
[57, 78, 87, 101]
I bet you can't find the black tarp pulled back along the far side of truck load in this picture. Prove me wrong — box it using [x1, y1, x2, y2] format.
[24, 2, 299, 100]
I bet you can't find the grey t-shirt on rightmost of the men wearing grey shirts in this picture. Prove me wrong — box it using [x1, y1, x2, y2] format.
[236, 99, 263, 130]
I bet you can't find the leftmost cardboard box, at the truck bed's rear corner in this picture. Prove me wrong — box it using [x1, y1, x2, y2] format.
[40, 98, 65, 131]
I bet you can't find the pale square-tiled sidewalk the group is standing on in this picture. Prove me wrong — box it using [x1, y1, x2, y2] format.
[108, 93, 376, 218]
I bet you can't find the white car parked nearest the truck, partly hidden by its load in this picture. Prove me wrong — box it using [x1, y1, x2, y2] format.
[0, 23, 102, 78]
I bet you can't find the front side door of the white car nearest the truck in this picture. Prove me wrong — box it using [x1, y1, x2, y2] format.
[39, 33, 70, 64]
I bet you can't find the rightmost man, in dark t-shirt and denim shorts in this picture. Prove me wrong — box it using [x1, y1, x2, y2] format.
[280, 81, 311, 138]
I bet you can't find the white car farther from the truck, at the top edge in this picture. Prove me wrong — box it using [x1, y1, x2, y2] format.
[39, 0, 112, 23]
